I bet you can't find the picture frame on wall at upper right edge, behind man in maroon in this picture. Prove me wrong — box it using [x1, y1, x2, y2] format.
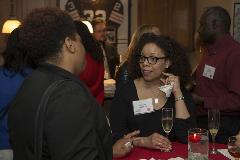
[233, 3, 240, 42]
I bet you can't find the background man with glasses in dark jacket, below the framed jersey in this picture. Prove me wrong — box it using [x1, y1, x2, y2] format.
[91, 18, 119, 79]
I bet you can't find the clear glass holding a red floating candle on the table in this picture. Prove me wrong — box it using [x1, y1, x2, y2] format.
[188, 128, 209, 160]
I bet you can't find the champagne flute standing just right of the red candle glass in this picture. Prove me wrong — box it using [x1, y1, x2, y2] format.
[208, 109, 220, 154]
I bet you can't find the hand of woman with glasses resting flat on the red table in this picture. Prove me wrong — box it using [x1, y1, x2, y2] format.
[133, 133, 172, 151]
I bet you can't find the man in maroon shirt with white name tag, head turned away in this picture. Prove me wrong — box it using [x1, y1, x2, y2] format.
[194, 6, 240, 143]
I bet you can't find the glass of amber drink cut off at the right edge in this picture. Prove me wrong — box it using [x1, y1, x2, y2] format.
[228, 136, 240, 160]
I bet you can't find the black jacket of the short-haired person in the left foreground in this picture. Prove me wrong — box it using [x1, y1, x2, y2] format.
[8, 64, 112, 160]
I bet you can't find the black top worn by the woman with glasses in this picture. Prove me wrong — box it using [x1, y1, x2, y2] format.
[110, 81, 196, 143]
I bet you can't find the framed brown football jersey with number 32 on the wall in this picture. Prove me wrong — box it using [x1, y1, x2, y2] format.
[59, 0, 130, 54]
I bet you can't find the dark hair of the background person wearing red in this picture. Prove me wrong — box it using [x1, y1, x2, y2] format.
[74, 21, 103, 63]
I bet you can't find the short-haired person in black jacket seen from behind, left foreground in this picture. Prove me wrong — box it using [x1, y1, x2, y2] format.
[8, 8, 112, 160]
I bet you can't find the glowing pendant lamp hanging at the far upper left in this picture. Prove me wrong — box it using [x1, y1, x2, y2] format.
[2, 0, 21, 33]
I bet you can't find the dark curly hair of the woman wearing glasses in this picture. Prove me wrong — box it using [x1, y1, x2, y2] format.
[128, 33, 191, 87]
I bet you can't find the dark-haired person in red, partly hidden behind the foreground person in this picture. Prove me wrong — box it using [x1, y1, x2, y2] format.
[75, 21, 104, 105]
